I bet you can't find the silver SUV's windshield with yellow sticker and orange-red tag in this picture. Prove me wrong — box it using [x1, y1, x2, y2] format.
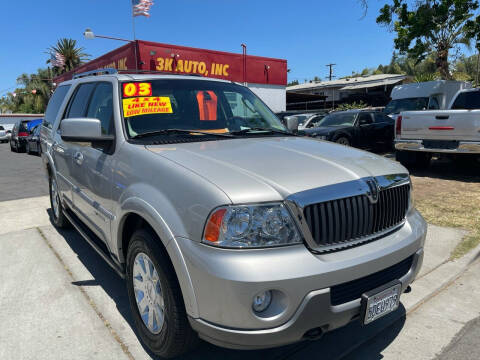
[122, 79, 287, 137]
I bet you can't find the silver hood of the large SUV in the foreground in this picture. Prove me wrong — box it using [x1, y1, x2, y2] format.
[146, 137, 407, 203]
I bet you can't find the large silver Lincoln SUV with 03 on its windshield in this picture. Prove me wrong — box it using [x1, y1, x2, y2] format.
[41, 70, 426, 357]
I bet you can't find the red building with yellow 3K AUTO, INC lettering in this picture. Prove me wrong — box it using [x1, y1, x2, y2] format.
[54, 40, 287, 111]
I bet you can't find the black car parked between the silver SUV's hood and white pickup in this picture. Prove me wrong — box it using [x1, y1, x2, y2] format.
[301, 110, 395, 149]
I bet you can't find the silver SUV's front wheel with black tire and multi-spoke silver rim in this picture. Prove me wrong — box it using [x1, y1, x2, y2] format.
[126, 229, 198, 358]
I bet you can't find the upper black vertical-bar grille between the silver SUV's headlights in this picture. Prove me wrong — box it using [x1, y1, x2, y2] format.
[304, 184, 410, 247]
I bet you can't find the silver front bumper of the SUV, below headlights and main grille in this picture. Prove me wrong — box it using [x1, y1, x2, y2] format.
[177, 211, 426, 349]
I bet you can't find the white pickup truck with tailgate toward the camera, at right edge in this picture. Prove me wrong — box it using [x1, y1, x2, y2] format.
[395, 88, 480, 167]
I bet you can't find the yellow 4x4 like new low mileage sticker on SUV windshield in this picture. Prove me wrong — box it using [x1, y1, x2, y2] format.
[123, 96, 173, 117]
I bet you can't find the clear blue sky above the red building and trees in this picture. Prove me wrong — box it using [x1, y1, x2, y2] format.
[0, 0, 394, 96]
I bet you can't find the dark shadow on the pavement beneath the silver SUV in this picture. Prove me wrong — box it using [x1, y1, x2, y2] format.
[48, 209, 405, 360]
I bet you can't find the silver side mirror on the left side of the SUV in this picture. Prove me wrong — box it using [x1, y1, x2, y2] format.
[60, 118, 114, 142]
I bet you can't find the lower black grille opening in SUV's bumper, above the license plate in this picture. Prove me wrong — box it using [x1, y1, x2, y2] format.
[330, 255, 413, 305]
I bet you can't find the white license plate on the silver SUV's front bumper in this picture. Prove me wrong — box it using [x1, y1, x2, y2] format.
[362, 281, 402, 325]
